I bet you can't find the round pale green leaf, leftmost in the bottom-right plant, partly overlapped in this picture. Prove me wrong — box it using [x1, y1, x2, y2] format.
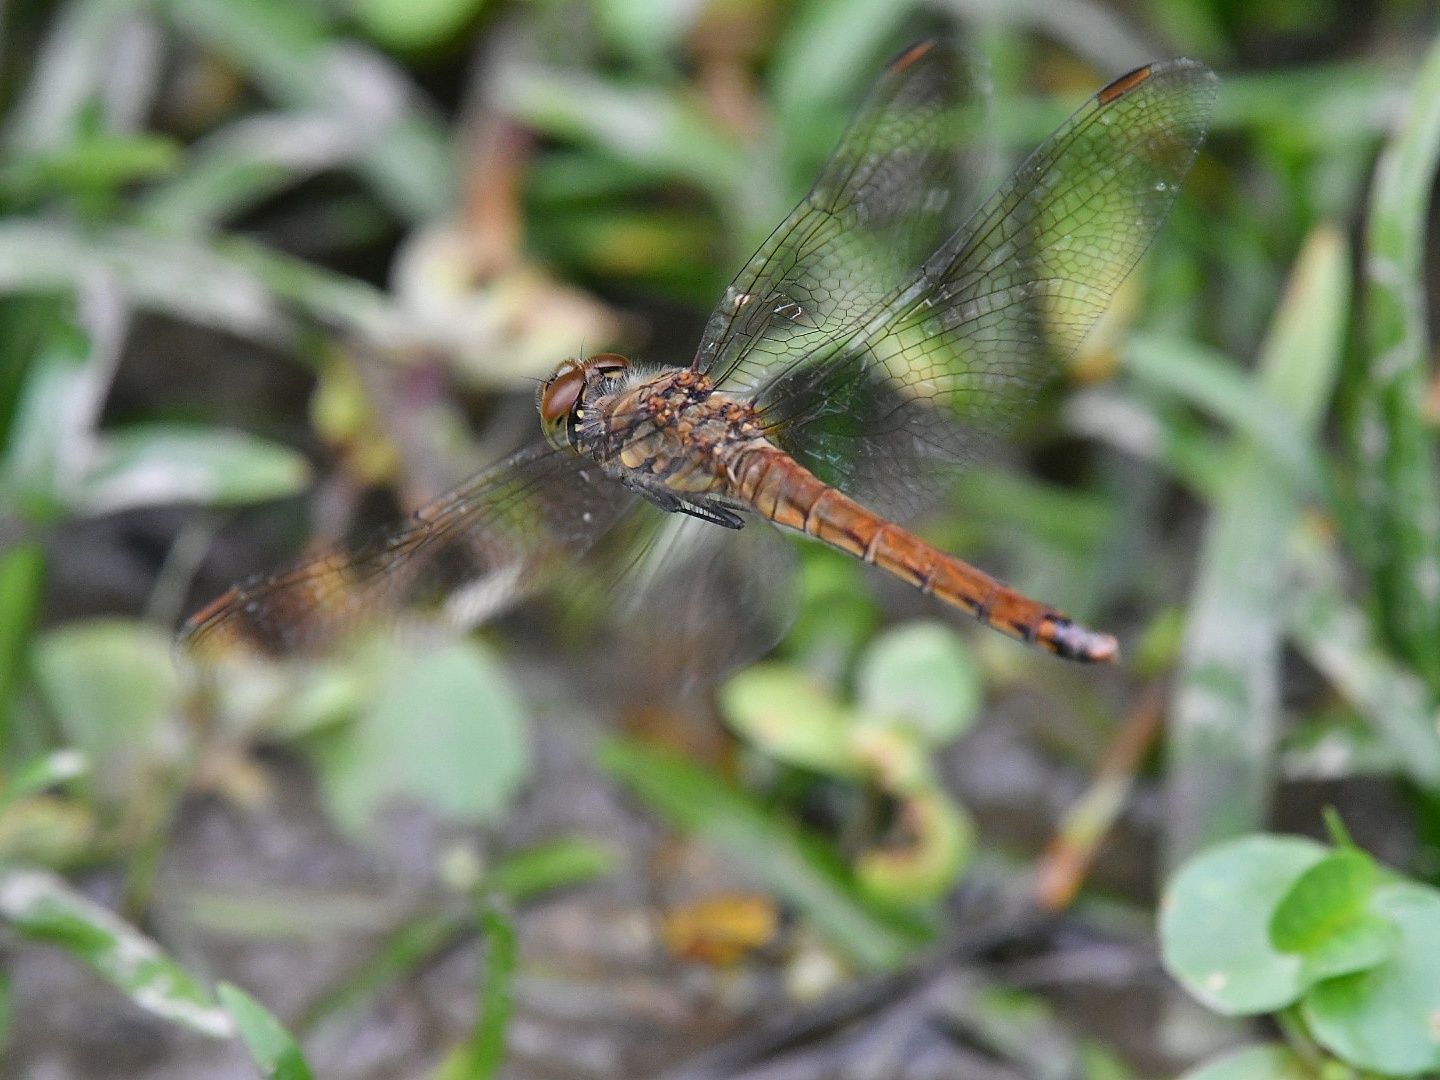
[1159, 834, 1326, 1017]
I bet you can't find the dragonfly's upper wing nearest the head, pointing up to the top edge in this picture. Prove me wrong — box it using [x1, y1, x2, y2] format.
[694, 42, 985, 403]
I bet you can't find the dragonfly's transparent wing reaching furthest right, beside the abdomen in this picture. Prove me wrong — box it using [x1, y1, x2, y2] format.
[759, 59, 1217, 515]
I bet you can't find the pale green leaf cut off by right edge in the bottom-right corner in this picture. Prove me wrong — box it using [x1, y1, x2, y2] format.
[1302, 881, 1440, 1076]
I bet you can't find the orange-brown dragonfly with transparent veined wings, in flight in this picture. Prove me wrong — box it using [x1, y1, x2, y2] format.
[181, 40, 1217, 662]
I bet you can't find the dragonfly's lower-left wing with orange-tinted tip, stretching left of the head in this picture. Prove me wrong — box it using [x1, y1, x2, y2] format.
[180, 446, 635, 660]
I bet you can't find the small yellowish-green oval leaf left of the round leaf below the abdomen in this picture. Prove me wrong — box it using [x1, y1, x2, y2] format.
[719, 664, 858, 776]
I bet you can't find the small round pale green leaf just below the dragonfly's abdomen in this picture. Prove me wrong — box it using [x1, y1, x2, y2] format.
[855, 622, 982, 743]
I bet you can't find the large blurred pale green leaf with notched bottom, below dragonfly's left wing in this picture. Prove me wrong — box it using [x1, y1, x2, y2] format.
[314, 641, 530, 835]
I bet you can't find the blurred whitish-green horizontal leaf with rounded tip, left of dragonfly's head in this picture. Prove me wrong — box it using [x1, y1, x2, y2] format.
[75, 423, 310, 514]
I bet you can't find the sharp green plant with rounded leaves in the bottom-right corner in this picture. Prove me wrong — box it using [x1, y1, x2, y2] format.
[1159, 834, 1440, 1080]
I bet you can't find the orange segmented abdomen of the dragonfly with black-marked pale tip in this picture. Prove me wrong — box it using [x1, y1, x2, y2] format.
[730, 444, 1119, 662]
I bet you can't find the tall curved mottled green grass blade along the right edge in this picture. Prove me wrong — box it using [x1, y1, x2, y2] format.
[1349, 42, 1440, 687]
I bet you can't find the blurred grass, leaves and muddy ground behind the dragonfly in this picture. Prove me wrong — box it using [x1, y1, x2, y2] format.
[0, 0, 1440, 1077]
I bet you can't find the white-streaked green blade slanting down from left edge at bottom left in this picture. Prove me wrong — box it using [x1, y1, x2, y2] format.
[0, 865, 232, 1038]
